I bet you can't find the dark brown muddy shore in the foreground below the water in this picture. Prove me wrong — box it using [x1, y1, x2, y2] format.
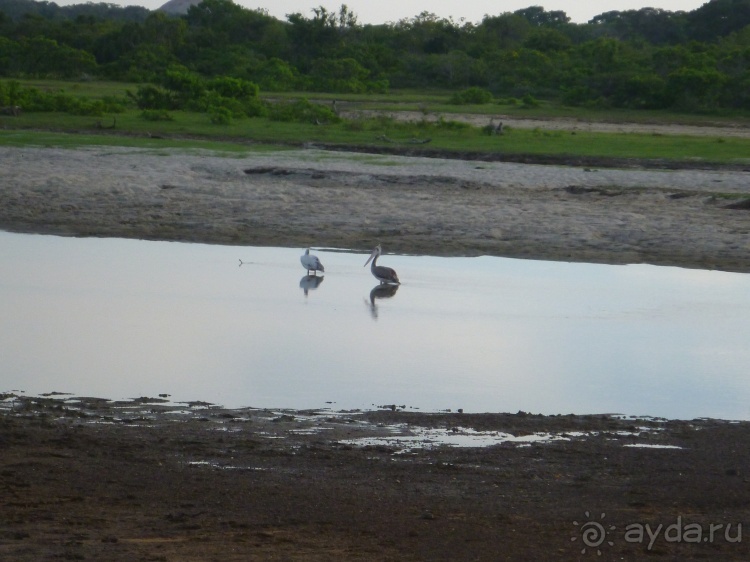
[0, 397, 750, 562]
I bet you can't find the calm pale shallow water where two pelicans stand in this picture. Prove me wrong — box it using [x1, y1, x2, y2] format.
[0, 233, 750, 419]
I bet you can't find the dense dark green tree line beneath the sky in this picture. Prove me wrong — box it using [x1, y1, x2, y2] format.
[0, 0, 750, 111]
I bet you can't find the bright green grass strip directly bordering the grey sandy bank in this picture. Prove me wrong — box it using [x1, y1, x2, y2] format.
[0, 110, 750, 164]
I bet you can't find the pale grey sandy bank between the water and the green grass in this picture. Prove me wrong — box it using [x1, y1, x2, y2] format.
[0, 144, 750, 271]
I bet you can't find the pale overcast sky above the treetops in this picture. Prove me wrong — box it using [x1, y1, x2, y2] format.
[53, 0, 708, 24]
